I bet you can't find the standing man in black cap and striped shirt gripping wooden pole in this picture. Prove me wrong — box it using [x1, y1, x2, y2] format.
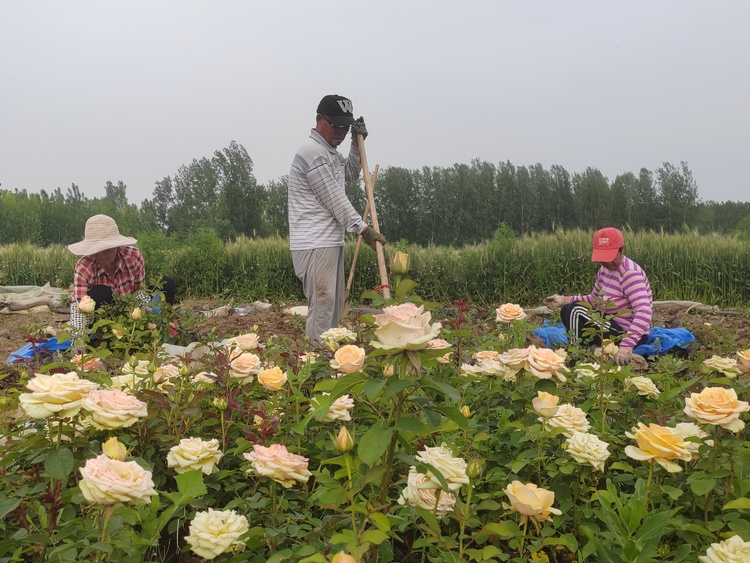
[288, 94, 386, 343]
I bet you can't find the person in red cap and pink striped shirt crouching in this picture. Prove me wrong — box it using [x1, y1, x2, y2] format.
[547, 227, 653, 365]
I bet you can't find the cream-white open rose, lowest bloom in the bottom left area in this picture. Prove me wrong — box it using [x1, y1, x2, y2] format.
[185, 508, 250, 561]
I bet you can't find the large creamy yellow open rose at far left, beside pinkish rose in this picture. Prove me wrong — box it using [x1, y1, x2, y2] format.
[18, 371, 98, 418]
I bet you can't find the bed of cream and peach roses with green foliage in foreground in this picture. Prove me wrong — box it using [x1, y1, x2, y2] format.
[0, 291, 750, 563]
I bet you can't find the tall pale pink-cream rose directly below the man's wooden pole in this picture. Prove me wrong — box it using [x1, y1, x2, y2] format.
[371, 303, 443, 351]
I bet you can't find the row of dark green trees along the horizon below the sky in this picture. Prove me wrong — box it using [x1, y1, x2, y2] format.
[0, 141, 750, 246]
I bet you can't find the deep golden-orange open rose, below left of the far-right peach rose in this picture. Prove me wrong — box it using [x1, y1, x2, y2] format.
[625, 422, 692, 473]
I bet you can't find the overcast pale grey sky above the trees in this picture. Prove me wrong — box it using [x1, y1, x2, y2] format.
[0, 0, 750, 204]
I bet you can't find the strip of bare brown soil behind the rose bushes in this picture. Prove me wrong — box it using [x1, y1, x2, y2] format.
[0, 299, 750, 390]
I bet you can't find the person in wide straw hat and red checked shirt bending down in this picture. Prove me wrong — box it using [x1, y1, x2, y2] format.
[68, 215, 175, 334]
